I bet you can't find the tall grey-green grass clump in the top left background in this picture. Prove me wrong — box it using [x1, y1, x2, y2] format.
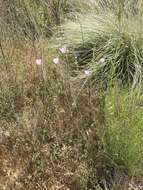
[0, 0, 93, 41]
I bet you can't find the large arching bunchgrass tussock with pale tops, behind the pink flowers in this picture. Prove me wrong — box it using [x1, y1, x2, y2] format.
[64, 11, 143, 87]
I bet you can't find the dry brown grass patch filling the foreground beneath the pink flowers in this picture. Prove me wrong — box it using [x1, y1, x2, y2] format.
[0, 39, 101, 189]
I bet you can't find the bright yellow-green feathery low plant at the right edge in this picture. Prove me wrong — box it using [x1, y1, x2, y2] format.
[104, 87, 143, 175]
